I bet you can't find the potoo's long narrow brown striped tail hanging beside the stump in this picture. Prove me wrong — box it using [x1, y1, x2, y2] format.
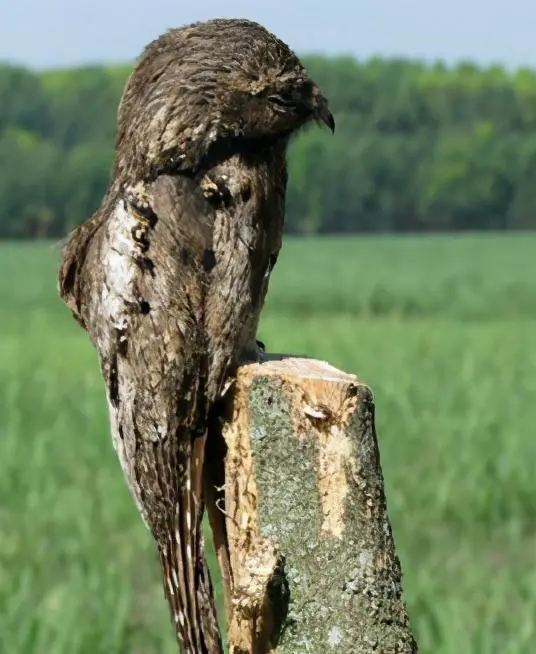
[159, 434, 223, 654]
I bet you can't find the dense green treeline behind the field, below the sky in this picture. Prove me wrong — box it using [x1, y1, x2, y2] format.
[0, 57, 536, 238]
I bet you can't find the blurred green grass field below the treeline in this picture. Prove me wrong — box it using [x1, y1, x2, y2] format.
[0, 235, 536, 654]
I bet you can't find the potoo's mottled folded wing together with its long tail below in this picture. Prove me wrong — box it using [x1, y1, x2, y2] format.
[60, 177, 224, 654]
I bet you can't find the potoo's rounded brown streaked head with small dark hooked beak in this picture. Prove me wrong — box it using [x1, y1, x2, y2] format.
[117, 19, 335, 179]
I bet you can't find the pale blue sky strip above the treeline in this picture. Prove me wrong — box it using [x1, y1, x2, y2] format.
[0, 0, 536, 68]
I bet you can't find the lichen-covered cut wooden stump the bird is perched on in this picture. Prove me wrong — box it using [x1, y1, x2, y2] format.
[209, 357, 417, 654]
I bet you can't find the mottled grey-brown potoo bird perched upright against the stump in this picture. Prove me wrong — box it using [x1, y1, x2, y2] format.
[59, 19, 334, 654]
